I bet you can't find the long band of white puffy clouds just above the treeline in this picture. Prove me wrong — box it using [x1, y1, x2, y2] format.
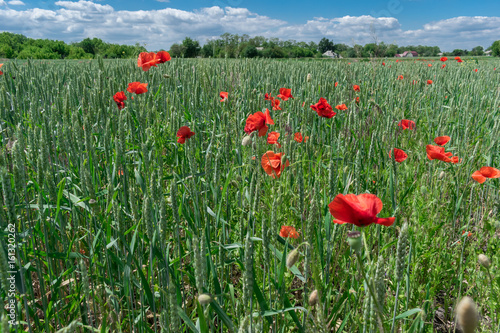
[0, 0, 500, 51]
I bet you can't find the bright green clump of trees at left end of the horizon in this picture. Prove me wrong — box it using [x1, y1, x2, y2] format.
[0, 32, 146, 59]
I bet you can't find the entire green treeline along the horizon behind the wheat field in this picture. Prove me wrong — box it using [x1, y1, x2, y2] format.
[0, 32, 500, 59]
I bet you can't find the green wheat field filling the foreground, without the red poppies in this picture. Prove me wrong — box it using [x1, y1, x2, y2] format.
[0, 58, 500, 333]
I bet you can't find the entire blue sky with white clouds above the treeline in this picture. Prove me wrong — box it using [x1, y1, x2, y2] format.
[0, 0, 500, 51]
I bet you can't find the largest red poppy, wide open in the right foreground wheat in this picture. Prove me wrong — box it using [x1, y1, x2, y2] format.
[328, 193, 396, 227]
